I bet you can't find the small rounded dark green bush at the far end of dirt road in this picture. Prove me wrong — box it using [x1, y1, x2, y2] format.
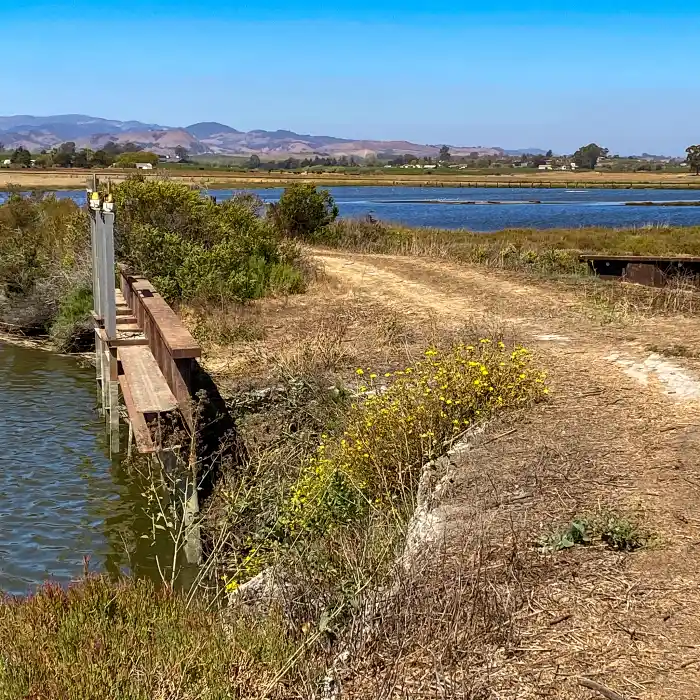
[268, 183, 338, 241]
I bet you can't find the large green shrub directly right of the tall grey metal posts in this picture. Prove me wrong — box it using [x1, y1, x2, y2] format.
[115, 177, 305, 303]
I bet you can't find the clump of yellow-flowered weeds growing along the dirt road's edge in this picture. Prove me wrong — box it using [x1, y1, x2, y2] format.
[284, 338, 548, 535]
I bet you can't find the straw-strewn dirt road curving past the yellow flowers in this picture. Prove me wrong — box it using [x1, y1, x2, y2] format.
[318, 252, 700, 700]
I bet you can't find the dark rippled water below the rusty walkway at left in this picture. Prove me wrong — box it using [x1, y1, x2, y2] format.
[0, 340, 165, 594]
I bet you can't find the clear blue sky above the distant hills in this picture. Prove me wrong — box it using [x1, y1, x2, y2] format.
[0, 0, 700, 154]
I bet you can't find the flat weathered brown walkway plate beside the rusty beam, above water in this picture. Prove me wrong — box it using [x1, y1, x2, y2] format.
[118, 345, 178, 414]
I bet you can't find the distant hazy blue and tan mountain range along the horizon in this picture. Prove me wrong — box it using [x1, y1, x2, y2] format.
[0, 114, 516, 159]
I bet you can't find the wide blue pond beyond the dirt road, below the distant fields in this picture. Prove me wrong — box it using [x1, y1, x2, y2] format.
[42, 187, 700, 231]
